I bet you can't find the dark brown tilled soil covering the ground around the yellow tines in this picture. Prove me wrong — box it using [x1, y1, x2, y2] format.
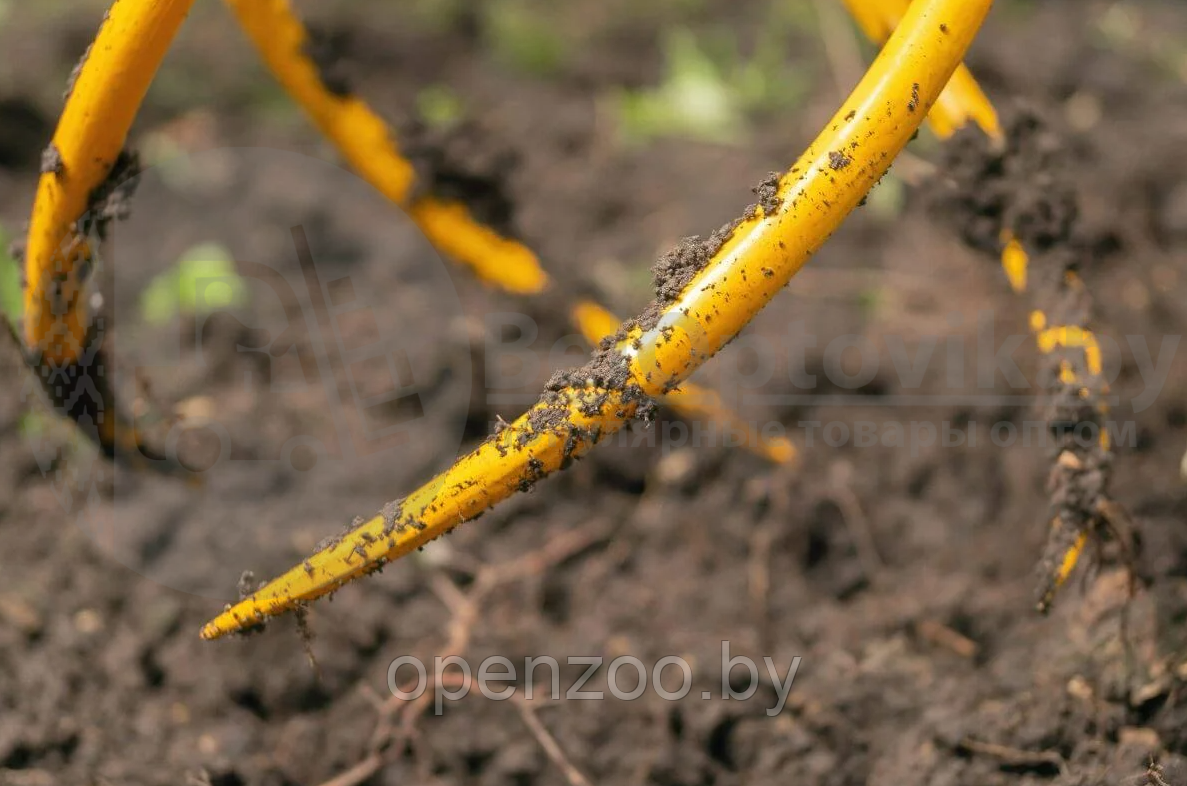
[0, 0, 1187, 786]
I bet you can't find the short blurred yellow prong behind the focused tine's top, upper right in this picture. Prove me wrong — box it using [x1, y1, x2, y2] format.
[843, 0, 1002, 140]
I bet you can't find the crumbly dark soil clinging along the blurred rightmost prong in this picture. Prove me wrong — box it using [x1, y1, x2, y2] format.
[931, 109, 1120, 610]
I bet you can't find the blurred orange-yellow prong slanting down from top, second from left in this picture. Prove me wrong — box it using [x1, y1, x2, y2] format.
[226, 0, 548, 294]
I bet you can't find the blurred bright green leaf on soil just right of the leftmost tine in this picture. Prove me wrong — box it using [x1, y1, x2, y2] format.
[140, 243, 248, 324]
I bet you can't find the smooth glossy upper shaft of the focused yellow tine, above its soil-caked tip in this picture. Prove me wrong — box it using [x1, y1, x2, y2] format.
[628, 0, 992, 395]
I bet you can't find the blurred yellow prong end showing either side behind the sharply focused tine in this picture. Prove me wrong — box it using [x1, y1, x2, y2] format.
[572, 300, 798, 464]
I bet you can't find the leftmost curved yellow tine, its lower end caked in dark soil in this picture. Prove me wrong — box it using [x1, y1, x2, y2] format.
[23, 0, 192, 470]
